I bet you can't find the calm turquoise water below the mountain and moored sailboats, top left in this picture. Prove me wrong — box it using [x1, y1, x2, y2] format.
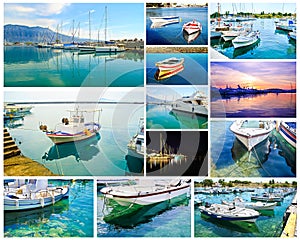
[4, 46, 144, 87]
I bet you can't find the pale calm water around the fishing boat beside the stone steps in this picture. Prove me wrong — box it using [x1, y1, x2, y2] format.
[5, 104, 143, 176]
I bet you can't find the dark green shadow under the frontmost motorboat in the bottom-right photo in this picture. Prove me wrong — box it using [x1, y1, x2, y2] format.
[201, 214, 259, 235]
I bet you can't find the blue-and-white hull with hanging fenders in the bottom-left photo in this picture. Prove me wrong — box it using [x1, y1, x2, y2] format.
[4, 187, 69, 211]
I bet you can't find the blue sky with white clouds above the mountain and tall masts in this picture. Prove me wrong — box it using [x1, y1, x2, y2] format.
[4, 2, 144, 40]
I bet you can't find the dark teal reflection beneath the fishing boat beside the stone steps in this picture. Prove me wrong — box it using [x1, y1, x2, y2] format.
[42, 133, 101, 161]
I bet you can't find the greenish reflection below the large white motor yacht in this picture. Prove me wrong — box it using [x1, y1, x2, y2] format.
[169, 110, 207, 129]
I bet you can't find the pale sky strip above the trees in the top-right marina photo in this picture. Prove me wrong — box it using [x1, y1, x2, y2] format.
[210, 1, 296, 13]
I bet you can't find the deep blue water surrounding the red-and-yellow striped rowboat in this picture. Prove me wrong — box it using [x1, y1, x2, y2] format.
[146, 53, 208, 85]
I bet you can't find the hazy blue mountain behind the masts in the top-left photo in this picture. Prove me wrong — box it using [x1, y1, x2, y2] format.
[4, 24, 86, 43]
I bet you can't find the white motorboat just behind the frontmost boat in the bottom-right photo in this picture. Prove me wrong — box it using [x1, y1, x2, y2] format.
[222, 197, 277, 211]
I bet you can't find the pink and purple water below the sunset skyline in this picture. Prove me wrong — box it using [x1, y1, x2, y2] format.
[211, 93, 296, 118]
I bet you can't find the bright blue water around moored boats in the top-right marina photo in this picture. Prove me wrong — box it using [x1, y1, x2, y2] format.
[211, 19, 296, 59]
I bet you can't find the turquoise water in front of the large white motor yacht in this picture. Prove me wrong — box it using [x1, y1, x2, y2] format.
[146, 104, 207, 129]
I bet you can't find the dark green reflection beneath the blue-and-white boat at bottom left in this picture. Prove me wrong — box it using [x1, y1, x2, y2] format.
[4, 199, 69, 227]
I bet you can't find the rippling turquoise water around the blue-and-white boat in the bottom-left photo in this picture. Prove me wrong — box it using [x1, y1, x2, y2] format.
[4, 180, 94, 237]
